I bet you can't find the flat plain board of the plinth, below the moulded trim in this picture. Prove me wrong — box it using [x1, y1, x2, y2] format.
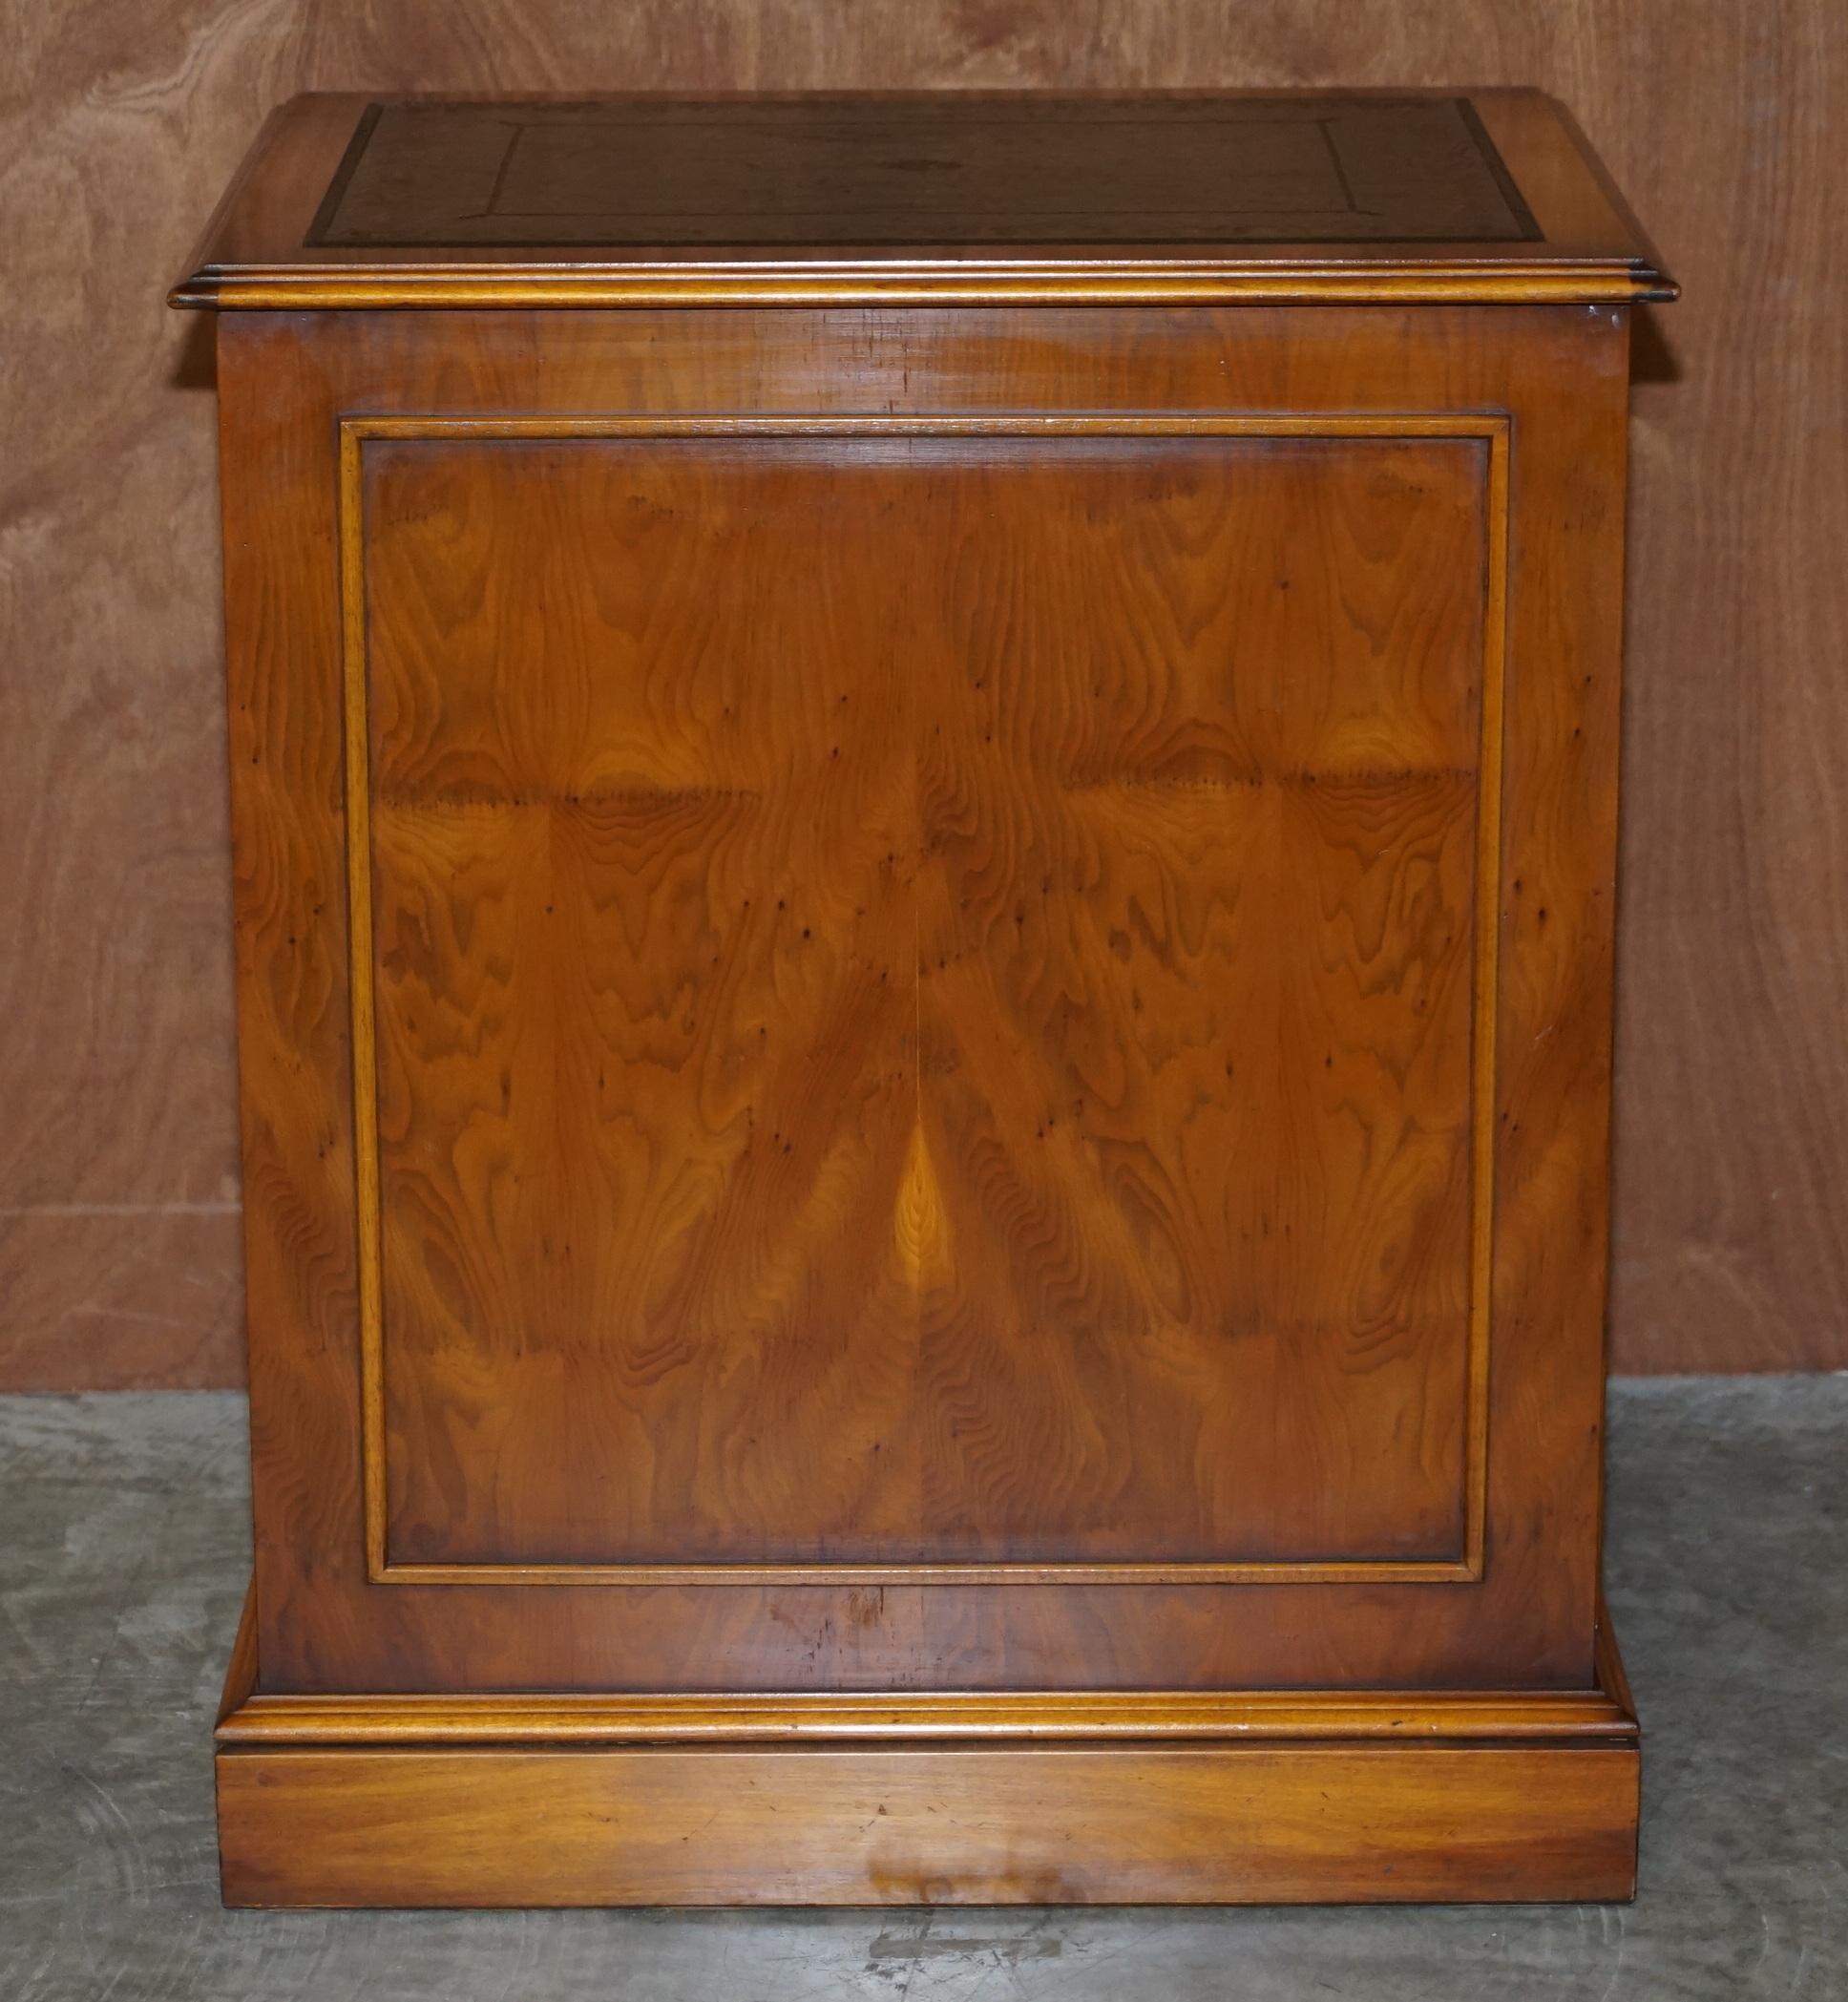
[219, 1746, 1638, 1906]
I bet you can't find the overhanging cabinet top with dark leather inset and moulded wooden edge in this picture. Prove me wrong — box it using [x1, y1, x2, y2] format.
[172, 90, 1671, 306]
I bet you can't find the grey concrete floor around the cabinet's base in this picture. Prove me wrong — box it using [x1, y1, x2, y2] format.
[0, 1376, 1848, 2002]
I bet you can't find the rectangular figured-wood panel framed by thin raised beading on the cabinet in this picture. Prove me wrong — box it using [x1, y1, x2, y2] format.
[348, 420, 1503, 1582]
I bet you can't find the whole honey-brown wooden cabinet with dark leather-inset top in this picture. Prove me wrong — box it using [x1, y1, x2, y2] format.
[174, 92, 1671, 1904]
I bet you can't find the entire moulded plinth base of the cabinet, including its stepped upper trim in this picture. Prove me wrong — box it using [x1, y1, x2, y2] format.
[219, 1612, 1640, 1906]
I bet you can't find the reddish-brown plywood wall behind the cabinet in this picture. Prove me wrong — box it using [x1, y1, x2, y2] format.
[0, 0, 1848, 1387]
